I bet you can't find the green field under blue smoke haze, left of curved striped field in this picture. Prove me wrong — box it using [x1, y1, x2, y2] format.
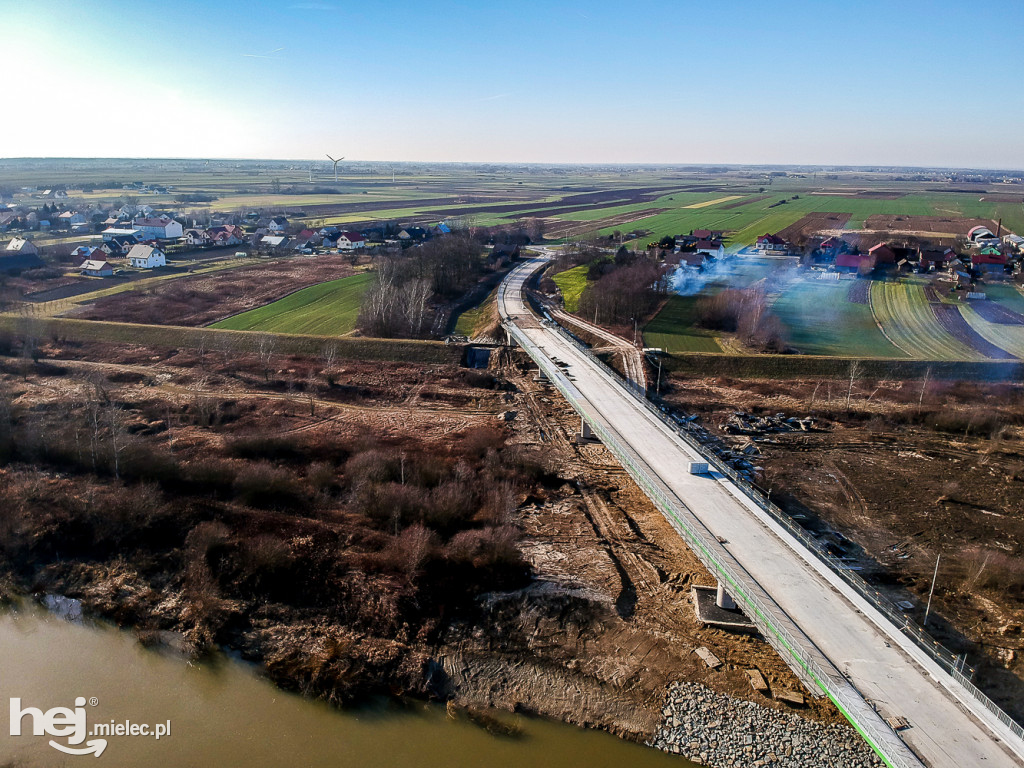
[772, 281, 906, 357]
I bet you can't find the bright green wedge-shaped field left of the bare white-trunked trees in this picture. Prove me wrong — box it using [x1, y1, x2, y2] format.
[210, 272, 373, 336]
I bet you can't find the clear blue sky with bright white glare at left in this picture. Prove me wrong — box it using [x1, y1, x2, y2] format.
[0, 0, 1024, 168]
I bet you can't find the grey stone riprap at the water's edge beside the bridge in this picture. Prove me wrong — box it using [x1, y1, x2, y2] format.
[649, 683, 885, 768]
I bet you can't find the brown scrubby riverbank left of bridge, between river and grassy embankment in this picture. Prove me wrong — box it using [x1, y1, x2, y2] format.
[0, 342, 864, 765]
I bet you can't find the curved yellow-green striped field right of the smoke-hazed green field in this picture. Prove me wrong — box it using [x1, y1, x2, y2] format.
[870, 283, 989, 360]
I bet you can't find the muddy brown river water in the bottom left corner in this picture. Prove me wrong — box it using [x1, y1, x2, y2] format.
[0, 605, 693, 768]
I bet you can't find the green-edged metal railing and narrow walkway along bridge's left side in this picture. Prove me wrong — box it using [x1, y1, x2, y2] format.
[503, 299, 921, 768]
